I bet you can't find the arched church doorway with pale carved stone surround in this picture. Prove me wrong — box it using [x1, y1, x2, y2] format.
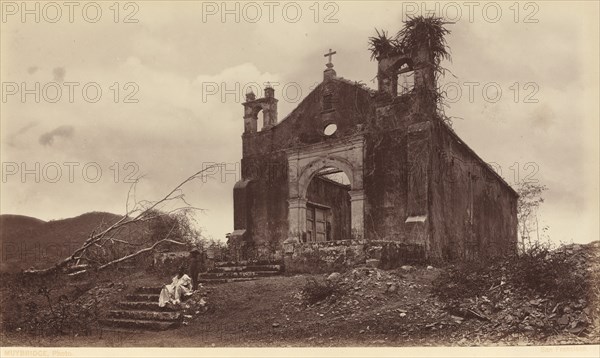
[288, 138, 365, 242]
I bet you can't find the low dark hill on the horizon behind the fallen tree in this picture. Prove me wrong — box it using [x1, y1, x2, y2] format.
[0, 212, 130, 272]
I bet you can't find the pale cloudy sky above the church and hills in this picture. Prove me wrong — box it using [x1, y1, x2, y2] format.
[0, 1, 599, 243]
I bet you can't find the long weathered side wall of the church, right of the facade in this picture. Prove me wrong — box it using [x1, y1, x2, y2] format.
[430, 123, 517, 260]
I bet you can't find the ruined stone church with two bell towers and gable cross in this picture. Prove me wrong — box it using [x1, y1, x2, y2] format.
[229, 37, 518, 271]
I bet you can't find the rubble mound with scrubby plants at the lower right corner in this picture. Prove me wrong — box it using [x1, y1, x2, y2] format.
[434, 242, 600, 343]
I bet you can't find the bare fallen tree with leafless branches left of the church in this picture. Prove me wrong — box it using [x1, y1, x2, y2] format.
[24, 164, 217, 276]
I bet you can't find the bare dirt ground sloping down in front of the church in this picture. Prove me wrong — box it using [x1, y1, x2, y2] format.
[1, 267, 598, 347]
